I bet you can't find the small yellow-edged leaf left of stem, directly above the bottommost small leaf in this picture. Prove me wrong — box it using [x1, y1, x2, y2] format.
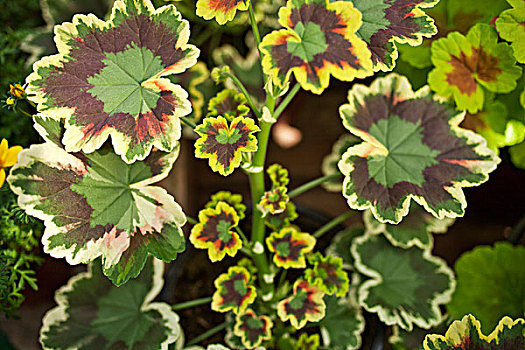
[211, 266, 257, 314]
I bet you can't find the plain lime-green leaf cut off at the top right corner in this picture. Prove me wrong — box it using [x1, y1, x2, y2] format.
[496, 0, 525, 63]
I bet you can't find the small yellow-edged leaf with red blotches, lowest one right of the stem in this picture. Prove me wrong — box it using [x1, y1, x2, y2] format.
[277, 279, 326, 329]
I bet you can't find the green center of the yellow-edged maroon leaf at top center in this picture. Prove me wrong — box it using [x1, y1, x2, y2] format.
[286, 22, 328, 62]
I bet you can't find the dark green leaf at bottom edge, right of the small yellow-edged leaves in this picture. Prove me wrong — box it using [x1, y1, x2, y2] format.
[319, 293, 365, 350]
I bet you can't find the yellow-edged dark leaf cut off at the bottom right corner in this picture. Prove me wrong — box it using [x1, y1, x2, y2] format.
[423, 315, 525, 350]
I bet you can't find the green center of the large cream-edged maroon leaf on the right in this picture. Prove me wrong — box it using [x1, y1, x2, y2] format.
[368, 116, 440, 188]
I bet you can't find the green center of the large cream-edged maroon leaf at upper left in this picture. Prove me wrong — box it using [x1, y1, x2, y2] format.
[87, 43, 164, 118]
